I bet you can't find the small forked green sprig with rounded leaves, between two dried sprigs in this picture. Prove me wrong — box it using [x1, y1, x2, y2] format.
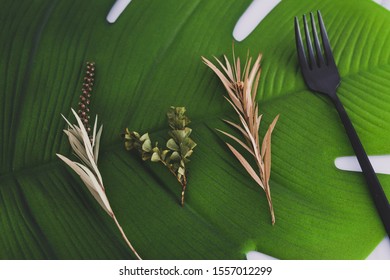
[123, 107, 196, 206]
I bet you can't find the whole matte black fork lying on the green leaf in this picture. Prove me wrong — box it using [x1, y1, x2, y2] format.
[295, 11, 390, 236]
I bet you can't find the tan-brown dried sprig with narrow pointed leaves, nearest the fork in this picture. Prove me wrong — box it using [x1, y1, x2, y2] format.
[202, 52, 279, 224]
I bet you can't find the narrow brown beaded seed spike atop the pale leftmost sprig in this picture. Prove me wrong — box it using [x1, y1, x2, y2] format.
[78, 62, 95, 133]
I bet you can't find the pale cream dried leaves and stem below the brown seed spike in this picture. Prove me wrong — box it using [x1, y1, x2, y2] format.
[57, 109, 141, 259]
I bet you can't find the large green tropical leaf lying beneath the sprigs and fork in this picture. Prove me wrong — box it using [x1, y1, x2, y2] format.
[0, 0, 390, 259]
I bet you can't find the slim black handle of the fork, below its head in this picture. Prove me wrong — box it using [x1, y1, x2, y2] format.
[332, 94, 390, 237]
